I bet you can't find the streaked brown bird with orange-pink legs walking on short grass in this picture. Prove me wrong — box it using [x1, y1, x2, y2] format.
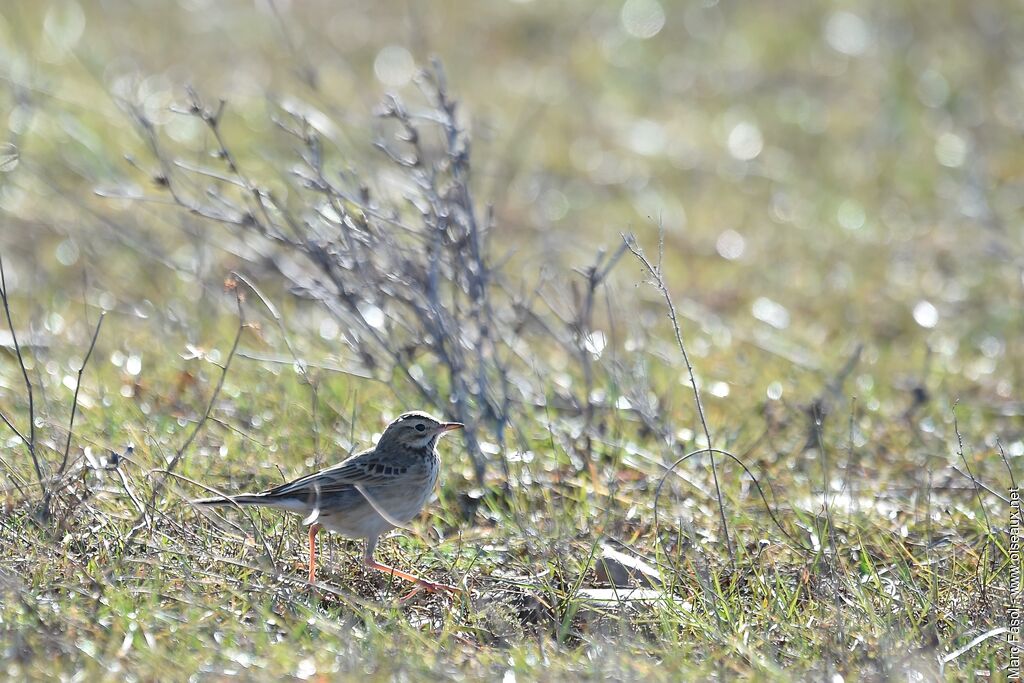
[191, 411, 465, 600]
